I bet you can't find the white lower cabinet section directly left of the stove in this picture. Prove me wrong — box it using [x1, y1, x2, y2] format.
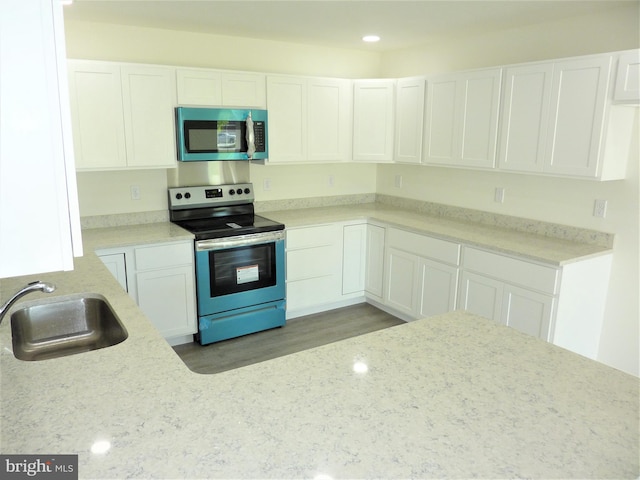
[96, 241, 198, 344]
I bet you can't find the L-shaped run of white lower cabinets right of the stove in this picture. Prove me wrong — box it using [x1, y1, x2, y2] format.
[286, 221, 612, 359]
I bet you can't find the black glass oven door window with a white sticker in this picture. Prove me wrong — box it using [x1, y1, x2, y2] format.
[209, 242, 277, 298]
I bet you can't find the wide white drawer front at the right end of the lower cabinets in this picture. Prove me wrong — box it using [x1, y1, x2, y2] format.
[463, 248, 558, 295]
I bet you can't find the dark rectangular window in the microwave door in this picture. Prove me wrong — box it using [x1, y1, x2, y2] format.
[184, 120, 247, 153]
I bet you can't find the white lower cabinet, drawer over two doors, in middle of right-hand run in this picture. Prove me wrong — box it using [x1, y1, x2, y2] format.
[383, 228, 460, 320]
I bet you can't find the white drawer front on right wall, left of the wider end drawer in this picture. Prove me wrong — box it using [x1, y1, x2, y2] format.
[387, 228, 460, 265]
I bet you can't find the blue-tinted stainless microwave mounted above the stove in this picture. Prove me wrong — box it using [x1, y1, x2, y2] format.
[176, 107, 269, 162]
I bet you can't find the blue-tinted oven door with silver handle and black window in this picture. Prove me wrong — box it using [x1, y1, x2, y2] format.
[196, 231, 285, 317]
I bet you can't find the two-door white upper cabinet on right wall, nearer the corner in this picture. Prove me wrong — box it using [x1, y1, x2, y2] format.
[424, 68, 502, 168]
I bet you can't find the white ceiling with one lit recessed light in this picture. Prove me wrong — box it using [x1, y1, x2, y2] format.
[65, 0, 639, 52]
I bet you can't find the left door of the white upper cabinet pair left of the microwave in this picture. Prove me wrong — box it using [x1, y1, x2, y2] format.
[68, 60, 127, 170]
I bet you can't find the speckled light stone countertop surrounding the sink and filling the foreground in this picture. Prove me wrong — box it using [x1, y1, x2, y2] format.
[0, 209, 640, 479]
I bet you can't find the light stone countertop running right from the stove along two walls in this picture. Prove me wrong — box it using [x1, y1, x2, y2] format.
[258, 203, 612, 266]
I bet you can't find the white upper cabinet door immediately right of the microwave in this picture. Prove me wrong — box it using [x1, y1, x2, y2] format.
[267, 76, 307, 163]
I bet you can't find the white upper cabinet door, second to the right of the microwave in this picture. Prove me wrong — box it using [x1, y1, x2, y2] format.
[307, 79, 352, 162]
